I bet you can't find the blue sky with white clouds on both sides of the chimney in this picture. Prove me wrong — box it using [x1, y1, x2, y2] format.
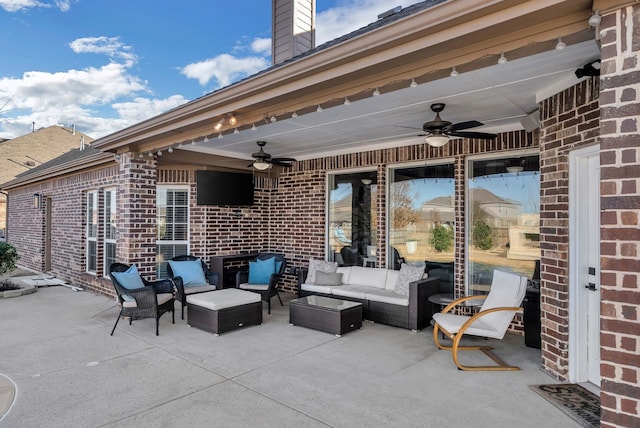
[0, 0, 418, 138]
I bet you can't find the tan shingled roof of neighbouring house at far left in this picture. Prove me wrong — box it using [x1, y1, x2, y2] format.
[0, 125, 93, 188]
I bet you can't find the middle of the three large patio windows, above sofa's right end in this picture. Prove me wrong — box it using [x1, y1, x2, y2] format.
[388, 163, 455, 274]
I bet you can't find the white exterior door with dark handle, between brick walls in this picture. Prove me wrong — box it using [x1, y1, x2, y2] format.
[569, 146, 600, 387]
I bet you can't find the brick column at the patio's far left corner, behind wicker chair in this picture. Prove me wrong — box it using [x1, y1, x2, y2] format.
[116, 153, 158, 279]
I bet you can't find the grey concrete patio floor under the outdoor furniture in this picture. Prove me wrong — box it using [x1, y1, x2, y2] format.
[0, 286, 580, 428]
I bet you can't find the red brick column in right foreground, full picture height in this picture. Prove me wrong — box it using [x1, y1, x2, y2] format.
[600, 5, 640, 427]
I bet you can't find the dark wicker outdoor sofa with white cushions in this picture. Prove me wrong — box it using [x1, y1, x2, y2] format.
[297, 260, 441, 331]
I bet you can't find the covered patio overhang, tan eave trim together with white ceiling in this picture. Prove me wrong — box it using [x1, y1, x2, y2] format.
[93, 0, 600, 170]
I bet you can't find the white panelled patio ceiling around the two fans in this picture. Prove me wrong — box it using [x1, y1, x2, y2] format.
[174, 40, 600, 168]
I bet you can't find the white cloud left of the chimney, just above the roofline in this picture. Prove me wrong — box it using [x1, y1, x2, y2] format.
[180, 54, 270, 88]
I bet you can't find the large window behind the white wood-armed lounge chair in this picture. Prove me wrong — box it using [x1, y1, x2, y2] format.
[466, 154, 540, 294]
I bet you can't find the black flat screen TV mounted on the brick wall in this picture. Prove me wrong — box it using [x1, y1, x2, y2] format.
[196, 171, 253, 206]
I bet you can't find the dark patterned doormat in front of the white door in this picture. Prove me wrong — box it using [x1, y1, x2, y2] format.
[530, 383, 600, 428]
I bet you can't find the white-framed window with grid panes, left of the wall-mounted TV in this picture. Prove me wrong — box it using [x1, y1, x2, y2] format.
[156, 186, 189, 278]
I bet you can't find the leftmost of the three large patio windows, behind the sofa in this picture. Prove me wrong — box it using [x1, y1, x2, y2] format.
[327, 171, 378, 266]
